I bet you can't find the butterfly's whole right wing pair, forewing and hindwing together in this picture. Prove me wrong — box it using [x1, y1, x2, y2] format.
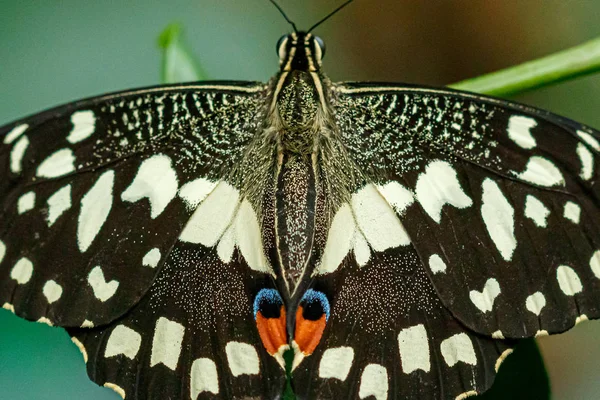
[293, 84, 600, 399]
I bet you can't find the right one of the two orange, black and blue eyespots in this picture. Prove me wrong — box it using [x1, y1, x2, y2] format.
[294, 289, 330, 356]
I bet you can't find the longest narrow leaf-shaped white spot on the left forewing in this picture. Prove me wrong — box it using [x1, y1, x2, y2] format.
[77, 170, 115, 253]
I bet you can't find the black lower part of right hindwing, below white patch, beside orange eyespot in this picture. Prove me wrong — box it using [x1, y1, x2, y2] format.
[293, 246, 514, 400]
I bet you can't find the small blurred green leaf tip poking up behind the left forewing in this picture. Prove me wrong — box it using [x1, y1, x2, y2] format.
[158, 23, 206, 83]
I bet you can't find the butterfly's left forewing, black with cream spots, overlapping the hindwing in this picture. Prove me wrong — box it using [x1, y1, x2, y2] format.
[0, 83, 262, 327]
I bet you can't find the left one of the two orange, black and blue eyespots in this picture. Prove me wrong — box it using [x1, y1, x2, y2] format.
[254, 289, 289, 361]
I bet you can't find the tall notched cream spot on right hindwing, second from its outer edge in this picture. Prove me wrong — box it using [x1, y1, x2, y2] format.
[398, 324, 431, 374]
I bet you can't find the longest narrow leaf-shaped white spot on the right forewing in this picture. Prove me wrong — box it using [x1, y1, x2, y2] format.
[481, 178, 517, 261]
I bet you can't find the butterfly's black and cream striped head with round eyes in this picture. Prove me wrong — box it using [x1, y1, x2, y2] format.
[277, 32, 325, 72]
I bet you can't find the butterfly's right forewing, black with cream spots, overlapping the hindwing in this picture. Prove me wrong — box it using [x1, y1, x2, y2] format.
[334, 84, 600, 338]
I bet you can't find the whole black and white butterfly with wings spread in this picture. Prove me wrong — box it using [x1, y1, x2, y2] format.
[0, 19, 600, 400]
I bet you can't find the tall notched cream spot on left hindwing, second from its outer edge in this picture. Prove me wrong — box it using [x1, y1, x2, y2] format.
[150, 317, 185, 371]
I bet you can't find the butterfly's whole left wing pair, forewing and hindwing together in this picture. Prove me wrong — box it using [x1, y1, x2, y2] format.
[0, 82, 285, 399]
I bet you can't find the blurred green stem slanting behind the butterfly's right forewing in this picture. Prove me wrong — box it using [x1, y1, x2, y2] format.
[449, 38, 600, 97]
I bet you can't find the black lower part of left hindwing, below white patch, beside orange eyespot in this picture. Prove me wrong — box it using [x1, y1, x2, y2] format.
[69, 241, 285, 400]
